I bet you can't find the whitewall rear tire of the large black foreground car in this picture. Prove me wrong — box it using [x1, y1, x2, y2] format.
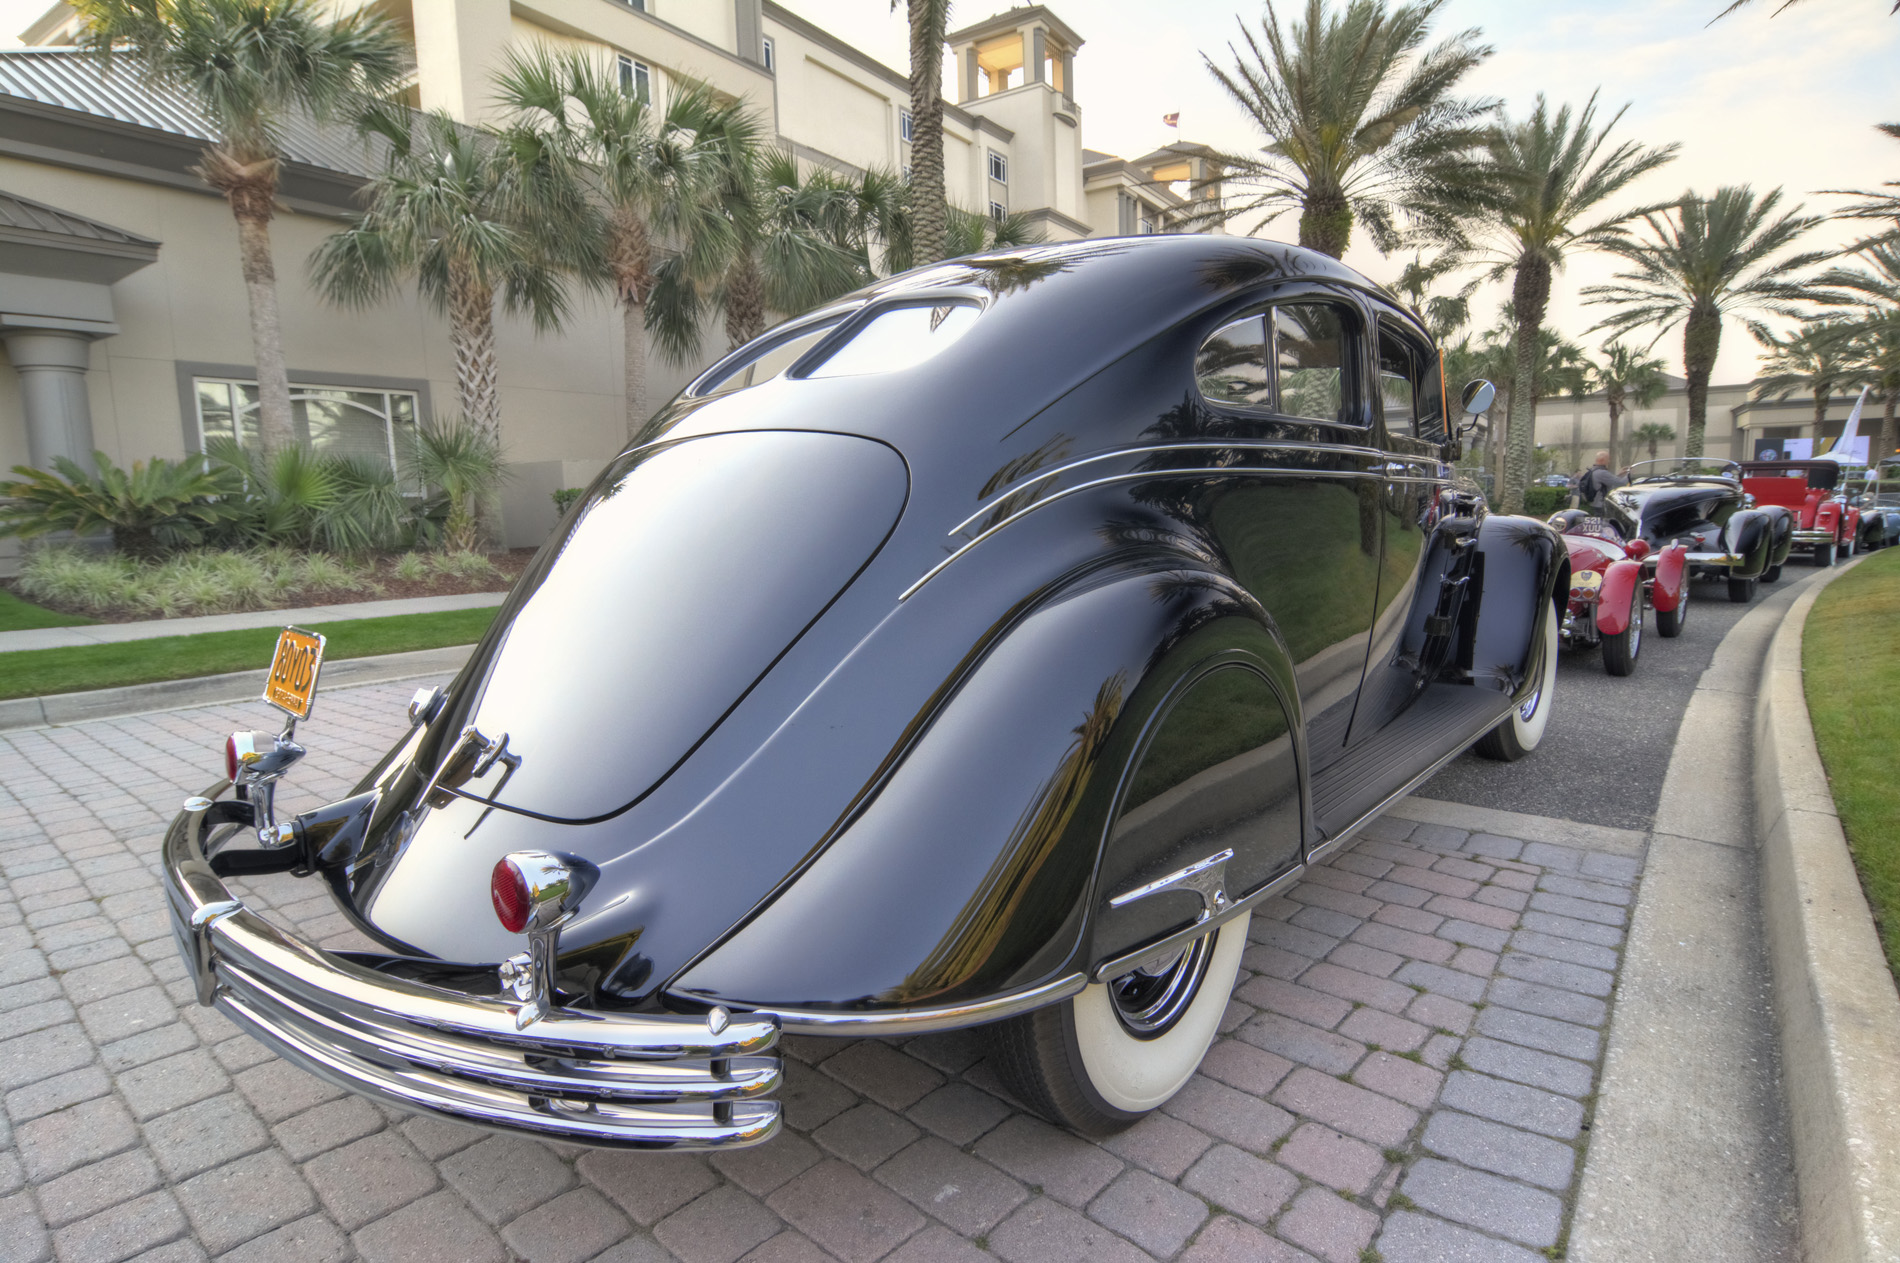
[986, 912, 1252, 1138]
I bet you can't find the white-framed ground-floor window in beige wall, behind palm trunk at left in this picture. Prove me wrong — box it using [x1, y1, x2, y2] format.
[192, 378, 422, 490]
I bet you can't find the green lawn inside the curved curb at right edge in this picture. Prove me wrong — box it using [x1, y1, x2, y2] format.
[1801, 549, 1900, 976]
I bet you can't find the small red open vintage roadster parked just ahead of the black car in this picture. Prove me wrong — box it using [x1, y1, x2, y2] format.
[1550, 509, 1689, 676]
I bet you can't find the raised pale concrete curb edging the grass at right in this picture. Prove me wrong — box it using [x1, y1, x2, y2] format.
[1754, 568, 1900, 1263]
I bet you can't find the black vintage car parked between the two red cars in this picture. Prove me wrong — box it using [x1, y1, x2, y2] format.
[1607, 456, 1794, 602]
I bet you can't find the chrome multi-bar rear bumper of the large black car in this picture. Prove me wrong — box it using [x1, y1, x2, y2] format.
[163, 786, 781, 1149]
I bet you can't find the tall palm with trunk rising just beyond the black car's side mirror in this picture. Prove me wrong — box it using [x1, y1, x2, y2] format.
[1436, 93, 1676, 513]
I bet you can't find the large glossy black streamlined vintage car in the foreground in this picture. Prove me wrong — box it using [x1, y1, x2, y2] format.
[165, 237, 1568, 1147]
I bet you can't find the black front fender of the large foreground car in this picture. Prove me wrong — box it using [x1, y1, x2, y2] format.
[1469, 513, 1569, 697]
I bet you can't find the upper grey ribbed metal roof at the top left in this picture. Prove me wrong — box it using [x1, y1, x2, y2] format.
[0, 47, 372, 179]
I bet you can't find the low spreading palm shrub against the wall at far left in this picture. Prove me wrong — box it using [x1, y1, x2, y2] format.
[0, 452, 238, 558]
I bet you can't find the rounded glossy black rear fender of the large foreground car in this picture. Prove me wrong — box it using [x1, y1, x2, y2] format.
[667, 570, 1305, 1014]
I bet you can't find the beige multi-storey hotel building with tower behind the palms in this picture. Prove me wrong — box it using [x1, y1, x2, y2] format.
[0, 0, 1218, 568]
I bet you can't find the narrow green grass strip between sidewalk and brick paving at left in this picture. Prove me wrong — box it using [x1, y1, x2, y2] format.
[0, 608, 496, 699]
